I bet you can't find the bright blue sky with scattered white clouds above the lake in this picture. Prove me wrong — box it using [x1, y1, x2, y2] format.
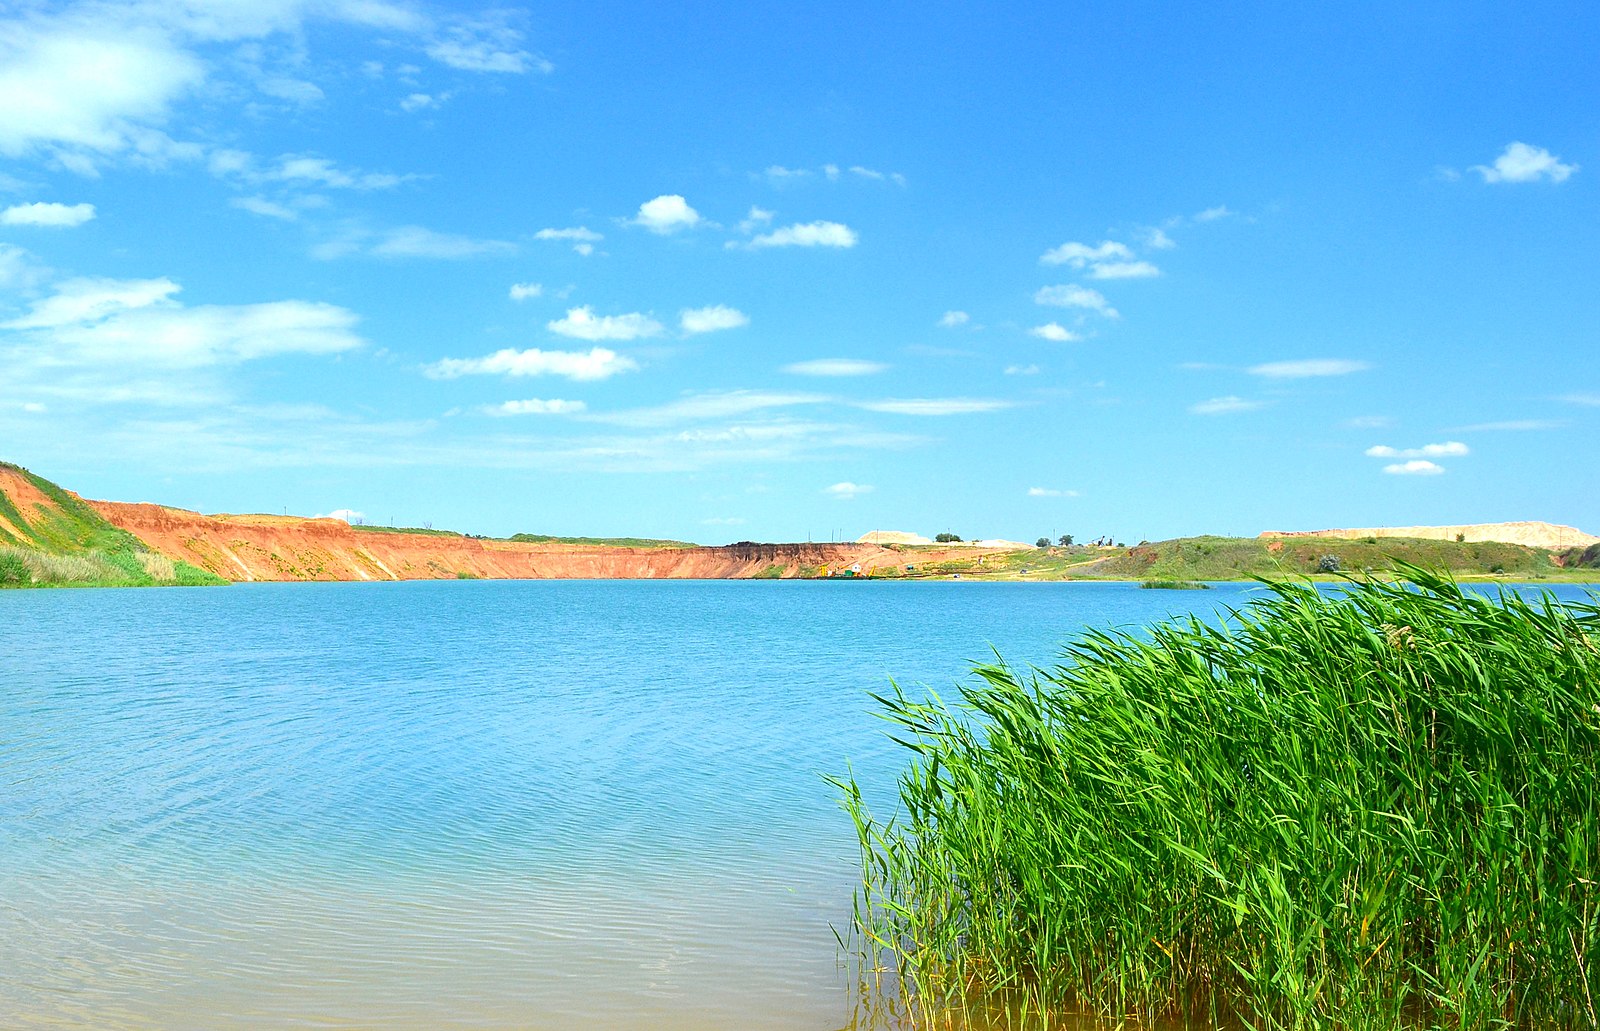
[0, 0, 1600, 543]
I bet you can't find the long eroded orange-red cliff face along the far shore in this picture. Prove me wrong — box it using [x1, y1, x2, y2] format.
[90, 501, 934, 581]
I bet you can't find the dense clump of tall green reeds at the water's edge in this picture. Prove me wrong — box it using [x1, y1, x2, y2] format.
[837, 567, 1600, 1029]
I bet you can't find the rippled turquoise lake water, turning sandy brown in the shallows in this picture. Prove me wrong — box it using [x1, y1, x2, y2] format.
[0, 581, 1582, 1031]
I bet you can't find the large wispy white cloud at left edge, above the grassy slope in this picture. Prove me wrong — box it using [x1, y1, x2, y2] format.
[0, 279, 365, 368]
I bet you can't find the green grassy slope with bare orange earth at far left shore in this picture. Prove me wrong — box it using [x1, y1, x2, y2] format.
[0, 463, 226, 588]
